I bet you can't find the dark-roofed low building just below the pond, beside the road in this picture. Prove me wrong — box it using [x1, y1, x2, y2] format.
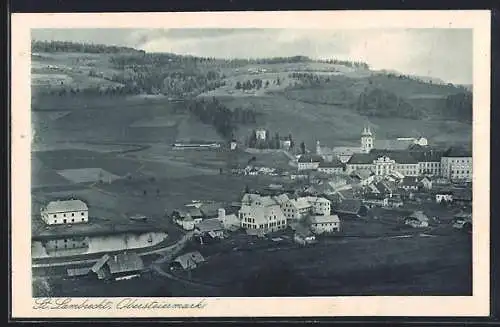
[90, 252, 144, 280]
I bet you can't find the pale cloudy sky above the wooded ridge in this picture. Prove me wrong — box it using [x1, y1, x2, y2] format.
[32, 28, 473, 84]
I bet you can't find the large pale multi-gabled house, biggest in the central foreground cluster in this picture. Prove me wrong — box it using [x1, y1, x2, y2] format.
[238, 194, 287, 235]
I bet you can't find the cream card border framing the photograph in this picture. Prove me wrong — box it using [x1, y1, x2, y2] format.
[11, 11, 490, 318]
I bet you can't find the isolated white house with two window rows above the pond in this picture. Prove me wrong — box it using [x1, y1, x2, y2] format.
[40, 199, 89, 225]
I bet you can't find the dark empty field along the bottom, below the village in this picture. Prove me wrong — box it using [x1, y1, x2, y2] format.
[37, 233, 472, 297]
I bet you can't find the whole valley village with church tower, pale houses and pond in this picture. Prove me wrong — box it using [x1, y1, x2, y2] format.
[33, 127, 472, 298]
